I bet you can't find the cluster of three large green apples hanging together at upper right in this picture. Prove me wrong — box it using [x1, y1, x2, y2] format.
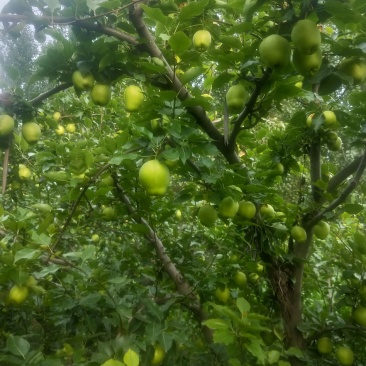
[259, 19, 322, 77]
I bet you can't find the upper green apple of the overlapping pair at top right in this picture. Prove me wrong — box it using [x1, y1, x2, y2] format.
[291, 19, 321, 55]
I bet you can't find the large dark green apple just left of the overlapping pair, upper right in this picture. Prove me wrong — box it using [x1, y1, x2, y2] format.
[259, 34, 291, 70]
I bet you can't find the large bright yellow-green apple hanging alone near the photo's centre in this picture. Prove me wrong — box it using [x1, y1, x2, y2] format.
[139, 159, 170, 196]
